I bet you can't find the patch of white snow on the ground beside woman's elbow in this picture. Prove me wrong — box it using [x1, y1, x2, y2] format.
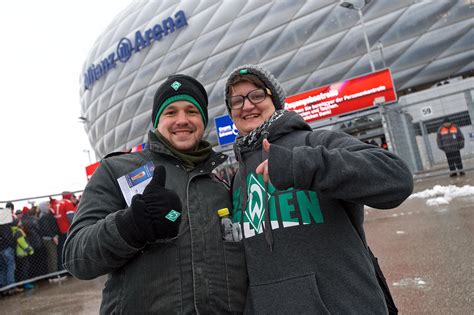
[409, 185, 474, 206]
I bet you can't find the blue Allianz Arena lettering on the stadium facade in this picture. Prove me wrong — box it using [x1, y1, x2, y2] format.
[84, 10, 188, 90]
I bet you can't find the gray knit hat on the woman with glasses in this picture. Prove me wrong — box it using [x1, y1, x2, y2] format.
[224, 65, 286, 114]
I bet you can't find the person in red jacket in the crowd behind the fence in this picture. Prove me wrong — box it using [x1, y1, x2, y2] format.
[50, 191, 77, 271]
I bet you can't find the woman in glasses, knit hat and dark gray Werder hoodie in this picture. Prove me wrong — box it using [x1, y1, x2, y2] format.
[225, 65, 413, 314]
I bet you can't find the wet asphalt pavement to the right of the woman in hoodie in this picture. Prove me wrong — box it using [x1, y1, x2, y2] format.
[365, 171, 474, 314]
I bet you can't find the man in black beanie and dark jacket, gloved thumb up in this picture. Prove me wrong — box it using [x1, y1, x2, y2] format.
[64, 74, 247, 314]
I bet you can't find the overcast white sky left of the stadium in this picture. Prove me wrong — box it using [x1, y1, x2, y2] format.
[0, 0, 132, 206]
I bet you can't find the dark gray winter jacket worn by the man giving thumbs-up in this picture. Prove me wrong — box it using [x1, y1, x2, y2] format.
[64, 132, 248, 314]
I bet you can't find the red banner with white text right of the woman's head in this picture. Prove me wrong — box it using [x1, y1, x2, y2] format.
[285, 68, 397, 122]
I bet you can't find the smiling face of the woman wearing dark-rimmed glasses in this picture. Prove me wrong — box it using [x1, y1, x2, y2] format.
[230, 81, 275, 135]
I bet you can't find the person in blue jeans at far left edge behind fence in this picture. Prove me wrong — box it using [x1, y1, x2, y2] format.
[0, 207, 23, 295]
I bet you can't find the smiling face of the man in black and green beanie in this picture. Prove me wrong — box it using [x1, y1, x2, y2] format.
[158, 101, 204, 151]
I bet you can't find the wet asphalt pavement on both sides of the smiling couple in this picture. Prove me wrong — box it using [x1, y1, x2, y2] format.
[0, 171, 474, 315]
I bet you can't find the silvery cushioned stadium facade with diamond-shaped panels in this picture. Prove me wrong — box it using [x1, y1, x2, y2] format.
[80, 0, 474, 160]
